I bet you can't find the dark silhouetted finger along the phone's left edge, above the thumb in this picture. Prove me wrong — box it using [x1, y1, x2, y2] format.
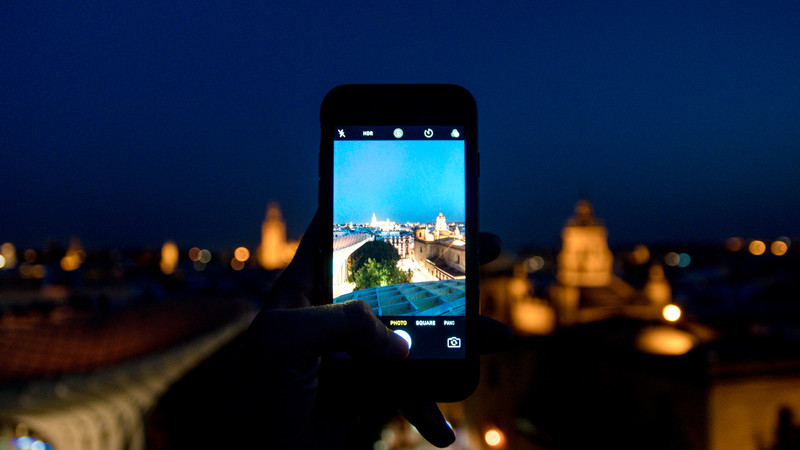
[269, 210, 320, 308]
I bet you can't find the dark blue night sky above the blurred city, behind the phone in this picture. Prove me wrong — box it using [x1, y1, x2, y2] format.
[0, 1, 800, 248]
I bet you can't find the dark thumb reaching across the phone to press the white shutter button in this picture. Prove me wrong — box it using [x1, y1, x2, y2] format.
[250, 300, 408, 367]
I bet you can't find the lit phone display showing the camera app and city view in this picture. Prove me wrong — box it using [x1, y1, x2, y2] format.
[331, 125, 471, 359]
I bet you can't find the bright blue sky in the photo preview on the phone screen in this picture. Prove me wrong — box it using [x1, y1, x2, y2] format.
[333, 141, 464, 223]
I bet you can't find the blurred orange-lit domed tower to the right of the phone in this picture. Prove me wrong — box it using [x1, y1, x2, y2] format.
[558, 199, 614, 287]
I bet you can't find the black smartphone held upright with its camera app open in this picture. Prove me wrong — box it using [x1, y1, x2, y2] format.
[319, 85, 479, 401]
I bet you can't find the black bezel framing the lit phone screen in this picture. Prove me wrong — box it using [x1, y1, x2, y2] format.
[319, 84, 480, 401]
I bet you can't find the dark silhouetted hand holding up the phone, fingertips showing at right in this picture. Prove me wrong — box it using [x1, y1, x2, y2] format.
[235, 215, 511, 448]
